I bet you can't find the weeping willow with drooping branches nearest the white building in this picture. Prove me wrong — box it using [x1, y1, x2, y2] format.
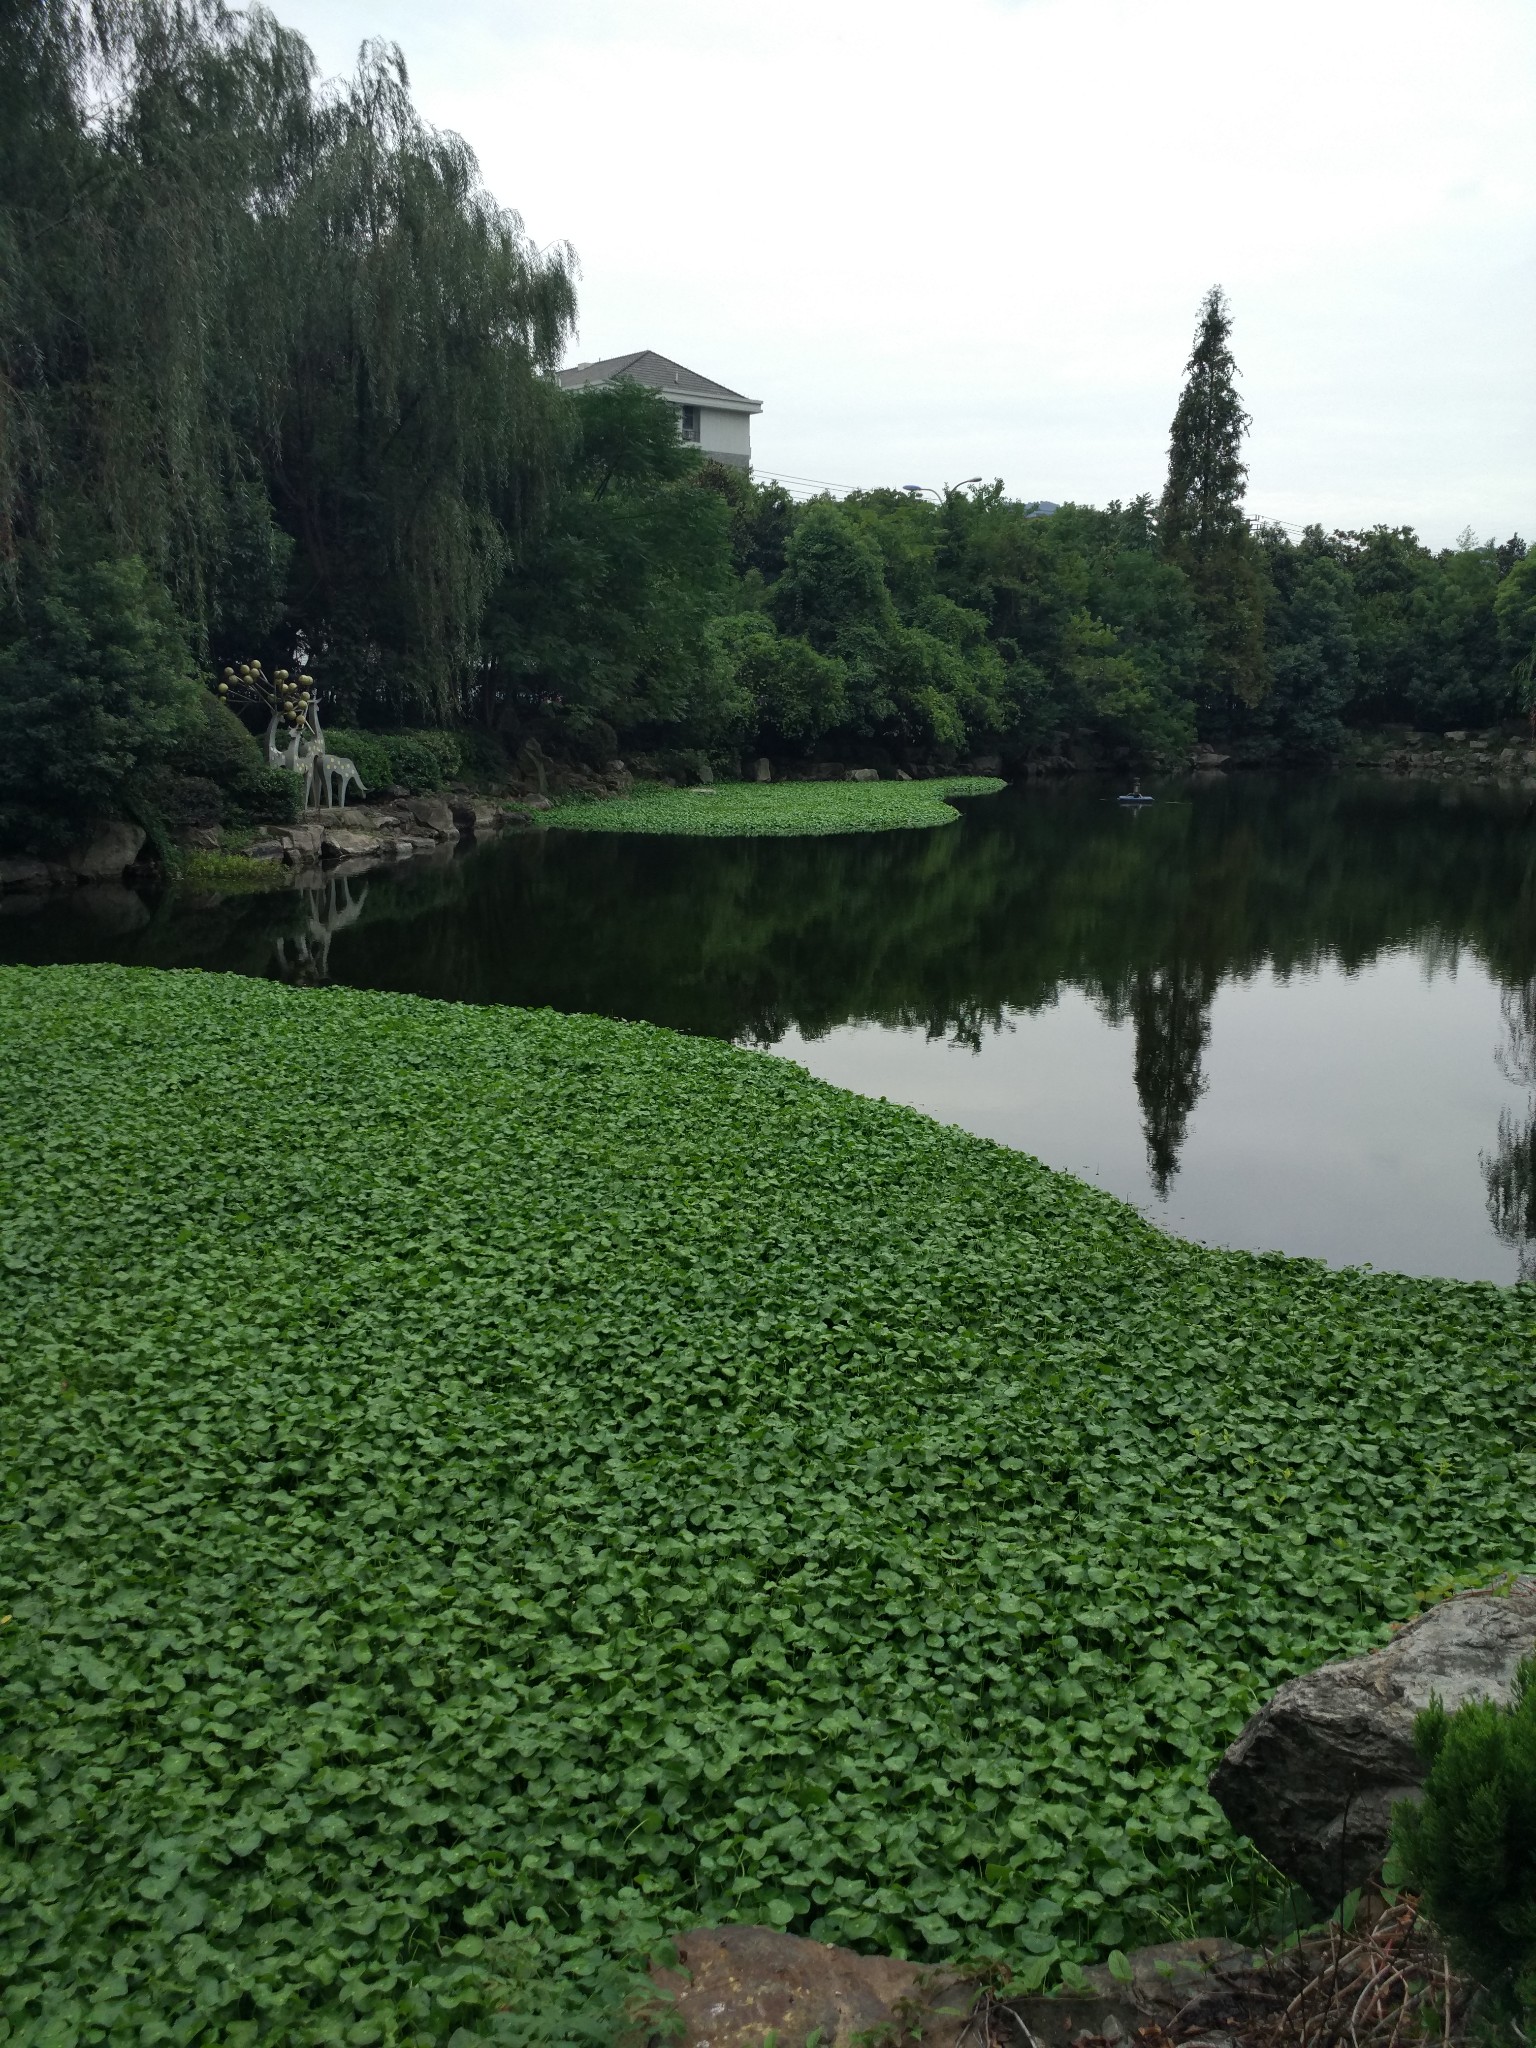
[264, 45, 575, 717]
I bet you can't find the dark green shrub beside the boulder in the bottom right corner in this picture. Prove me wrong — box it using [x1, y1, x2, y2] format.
[1395, 1661, 1536, 2019]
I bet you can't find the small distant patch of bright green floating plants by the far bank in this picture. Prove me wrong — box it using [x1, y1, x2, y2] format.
[547, 776, 1006, 840]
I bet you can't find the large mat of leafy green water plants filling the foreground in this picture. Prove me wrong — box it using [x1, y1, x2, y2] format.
[0, 967, 1536, 2044]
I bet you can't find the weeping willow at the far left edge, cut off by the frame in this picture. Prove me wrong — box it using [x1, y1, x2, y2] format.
[0, 0, 311, 606]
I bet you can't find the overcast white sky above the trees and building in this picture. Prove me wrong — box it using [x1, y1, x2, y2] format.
[274, 0, 1536, 545]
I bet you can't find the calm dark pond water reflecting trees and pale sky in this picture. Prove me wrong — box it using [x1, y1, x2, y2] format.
[0, 776, 1536, 1280]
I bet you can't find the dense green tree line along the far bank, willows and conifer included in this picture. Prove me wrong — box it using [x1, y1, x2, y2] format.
[0, 0, 1536, 831]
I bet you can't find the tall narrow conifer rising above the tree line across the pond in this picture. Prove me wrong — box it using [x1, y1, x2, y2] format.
[1157, 285, 1268, 705]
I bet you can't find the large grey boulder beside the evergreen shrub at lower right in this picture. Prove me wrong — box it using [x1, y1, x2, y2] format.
[1210, 1577, 1536, 1909]
